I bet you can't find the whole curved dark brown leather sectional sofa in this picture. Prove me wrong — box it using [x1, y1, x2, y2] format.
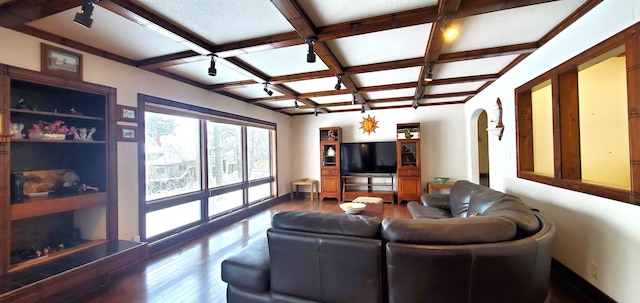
[222, 181, 555, 303]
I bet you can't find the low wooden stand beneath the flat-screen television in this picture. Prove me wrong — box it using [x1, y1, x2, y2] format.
[342, 174, 395, 204]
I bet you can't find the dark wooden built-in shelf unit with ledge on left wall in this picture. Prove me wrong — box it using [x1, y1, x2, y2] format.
[0, 65, 147, 302]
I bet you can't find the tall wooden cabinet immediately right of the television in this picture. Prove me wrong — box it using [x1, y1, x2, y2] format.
[396, 123, 422, 202]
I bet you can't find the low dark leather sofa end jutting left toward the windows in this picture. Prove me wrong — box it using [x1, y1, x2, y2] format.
[221, 237, 271, 293]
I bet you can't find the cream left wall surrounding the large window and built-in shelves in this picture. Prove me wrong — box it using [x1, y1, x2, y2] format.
[0, 27, 292, 240]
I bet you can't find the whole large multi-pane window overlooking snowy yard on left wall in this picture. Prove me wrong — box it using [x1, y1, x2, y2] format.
[138, 95, 277, 242]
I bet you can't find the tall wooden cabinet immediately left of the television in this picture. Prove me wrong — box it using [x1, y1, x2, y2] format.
[320, 127, 342, 201]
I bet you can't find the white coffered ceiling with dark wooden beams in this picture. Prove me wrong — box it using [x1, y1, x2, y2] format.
[0, 0, 601, 115]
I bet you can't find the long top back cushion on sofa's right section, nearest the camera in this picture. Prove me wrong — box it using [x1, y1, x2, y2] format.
[382, 216, 516, 244]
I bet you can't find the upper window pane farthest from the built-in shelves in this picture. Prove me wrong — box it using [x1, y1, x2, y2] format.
[247, 127, 271, 180]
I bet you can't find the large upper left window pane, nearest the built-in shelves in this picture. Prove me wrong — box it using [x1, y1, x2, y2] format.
[145, 112, 202, 201]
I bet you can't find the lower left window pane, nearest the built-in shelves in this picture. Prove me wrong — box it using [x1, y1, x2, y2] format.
[147, 200, 200, 238]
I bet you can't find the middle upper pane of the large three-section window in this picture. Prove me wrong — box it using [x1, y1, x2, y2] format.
[207, 122, 242, 186]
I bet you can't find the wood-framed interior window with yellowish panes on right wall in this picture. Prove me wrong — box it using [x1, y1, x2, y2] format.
[516, 25, 640, 204]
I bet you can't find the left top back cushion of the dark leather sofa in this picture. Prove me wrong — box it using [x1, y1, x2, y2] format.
[271, 211, 380, 239]
